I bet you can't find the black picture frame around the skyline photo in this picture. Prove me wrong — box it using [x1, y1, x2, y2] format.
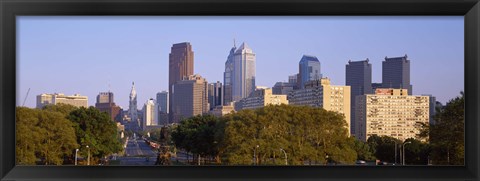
[0, 0, 480, 181]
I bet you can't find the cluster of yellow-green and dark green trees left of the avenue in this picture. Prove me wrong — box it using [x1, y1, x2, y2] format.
[16, 104, 122, 165]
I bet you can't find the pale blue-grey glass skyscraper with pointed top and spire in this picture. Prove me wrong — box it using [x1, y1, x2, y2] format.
[223, 42, 256, 105]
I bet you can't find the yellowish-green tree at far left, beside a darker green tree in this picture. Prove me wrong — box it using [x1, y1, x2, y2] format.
[16, 107, 78, 165]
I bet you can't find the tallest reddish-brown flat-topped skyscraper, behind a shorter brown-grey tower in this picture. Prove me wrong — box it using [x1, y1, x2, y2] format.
[168, 42, 194, 122]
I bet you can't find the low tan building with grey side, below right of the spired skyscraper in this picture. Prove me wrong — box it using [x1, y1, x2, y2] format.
[235, 86, 288, 110]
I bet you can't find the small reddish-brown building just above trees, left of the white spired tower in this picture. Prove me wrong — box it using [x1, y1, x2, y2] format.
[95, 92, 122, 122]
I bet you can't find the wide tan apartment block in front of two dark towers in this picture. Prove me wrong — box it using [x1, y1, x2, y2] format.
[355, 88, 429, 141]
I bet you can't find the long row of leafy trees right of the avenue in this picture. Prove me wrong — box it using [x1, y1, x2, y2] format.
[172, 93, 464, 165]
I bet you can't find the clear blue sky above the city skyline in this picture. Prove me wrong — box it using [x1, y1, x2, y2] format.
[17, 16, 464, 109]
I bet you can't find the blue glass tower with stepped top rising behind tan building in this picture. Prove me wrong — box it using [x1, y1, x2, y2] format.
[297, 55, 322, 89]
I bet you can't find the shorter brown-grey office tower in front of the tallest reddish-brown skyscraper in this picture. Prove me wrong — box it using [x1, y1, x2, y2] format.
[171, 75, 209, 122]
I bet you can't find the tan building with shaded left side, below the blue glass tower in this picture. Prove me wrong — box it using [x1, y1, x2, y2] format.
[288, 78, 350, 136]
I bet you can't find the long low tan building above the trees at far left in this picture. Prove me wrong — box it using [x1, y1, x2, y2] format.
[37, 93, 88, 109]
